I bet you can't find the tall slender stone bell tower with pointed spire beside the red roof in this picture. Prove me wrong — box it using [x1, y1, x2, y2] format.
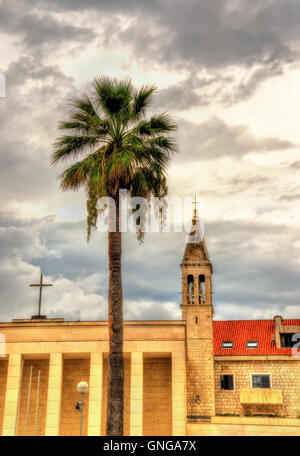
[180, 209, 215, 422]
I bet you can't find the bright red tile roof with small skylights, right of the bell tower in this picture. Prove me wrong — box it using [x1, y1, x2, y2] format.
[213, 320, 300, 356]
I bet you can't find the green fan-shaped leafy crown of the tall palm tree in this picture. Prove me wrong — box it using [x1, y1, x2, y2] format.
[51, 77, 177, 239]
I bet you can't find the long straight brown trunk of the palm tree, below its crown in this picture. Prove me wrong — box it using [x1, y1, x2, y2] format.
[106, 195, 124, 436]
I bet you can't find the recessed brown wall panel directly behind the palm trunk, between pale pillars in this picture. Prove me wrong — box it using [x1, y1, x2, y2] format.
[101, 357, 131, 436]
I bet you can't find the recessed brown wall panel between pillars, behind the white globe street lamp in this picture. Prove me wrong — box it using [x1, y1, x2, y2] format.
[59, 358, 90, 436]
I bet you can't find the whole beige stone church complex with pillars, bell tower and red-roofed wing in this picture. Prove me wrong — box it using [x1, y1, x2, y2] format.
[0, 213, 300, 436]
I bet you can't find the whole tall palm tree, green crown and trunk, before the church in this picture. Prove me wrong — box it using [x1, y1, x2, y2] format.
[52, 77, 177, 436]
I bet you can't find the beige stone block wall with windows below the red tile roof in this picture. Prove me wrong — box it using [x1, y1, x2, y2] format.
[215, 360, 300, 418]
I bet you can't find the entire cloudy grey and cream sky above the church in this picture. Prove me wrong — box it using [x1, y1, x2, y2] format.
[0, 0, 300, 321]
